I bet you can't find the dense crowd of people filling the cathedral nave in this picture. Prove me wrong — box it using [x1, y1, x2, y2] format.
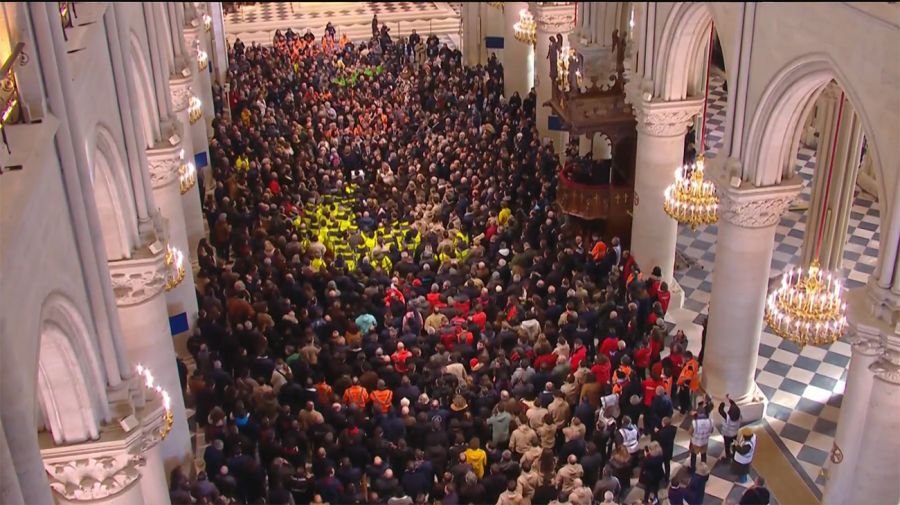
[171, 22, 767, 505]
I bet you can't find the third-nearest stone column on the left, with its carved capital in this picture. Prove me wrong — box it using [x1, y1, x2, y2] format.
[147, 128, 199, 344]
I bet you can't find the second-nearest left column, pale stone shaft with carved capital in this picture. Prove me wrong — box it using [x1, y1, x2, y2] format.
[109, 242, 191, 468]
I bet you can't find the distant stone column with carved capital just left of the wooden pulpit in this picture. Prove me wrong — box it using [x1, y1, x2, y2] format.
[530, 2, 575, 152]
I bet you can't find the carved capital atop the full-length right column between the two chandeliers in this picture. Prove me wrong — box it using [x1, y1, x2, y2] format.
[707, 164, 802, 228]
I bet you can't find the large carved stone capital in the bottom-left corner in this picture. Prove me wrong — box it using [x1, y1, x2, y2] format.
[41, 398, 167, 501]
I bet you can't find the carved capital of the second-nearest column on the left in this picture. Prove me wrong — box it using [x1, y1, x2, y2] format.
[109, 245, 168, 307]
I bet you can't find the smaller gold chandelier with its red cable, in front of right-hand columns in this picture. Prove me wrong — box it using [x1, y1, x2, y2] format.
[663, 22, 719, 230]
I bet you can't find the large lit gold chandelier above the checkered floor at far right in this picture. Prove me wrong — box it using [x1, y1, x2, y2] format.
[765, 259, 847, 347]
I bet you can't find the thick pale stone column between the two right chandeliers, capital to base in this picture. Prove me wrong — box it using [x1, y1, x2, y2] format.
[704, 173, 801, 422]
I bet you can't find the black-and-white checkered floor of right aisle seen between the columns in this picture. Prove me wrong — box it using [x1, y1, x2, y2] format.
[675, 77, 880, 496]
